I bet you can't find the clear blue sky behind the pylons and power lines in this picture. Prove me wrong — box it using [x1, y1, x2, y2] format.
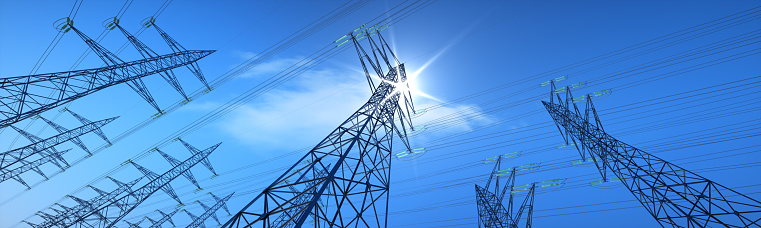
[0, 0, 761, 227]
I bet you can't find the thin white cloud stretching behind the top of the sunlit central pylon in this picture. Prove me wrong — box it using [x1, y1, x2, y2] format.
[218, 57, 488, 153]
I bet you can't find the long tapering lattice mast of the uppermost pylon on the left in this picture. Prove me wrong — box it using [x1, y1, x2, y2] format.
[0, 19, 214, 128]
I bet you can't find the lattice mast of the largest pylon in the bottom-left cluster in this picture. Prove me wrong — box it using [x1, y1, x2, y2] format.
[50, 144, 219, 227]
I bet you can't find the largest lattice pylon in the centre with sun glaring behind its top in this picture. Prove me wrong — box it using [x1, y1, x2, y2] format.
[223, 28, 414, 227]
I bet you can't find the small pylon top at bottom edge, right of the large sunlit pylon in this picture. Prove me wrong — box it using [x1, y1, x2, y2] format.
[476, 155, 536, 228]
